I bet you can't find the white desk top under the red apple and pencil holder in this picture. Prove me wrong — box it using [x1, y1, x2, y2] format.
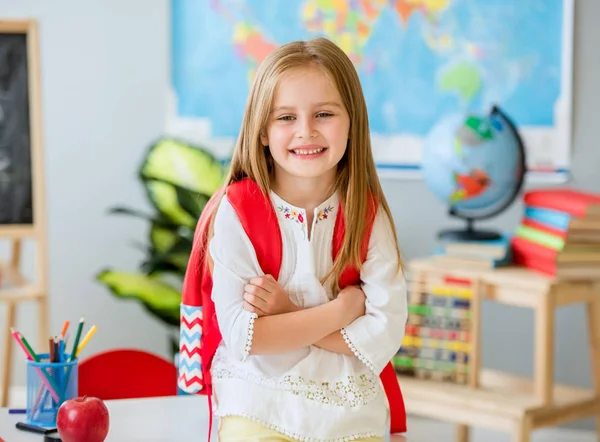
[0, 396, 406, 442]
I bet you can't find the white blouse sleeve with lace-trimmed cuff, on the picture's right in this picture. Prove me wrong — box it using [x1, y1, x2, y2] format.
[341, 210, 408, 374]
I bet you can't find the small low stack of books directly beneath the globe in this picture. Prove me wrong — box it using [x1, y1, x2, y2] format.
[433, 235, 511, 270]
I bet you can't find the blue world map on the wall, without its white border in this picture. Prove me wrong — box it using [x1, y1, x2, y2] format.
[171, 0, 564, 178]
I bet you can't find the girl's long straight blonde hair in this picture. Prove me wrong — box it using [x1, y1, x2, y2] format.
[213, 38, 403, 290]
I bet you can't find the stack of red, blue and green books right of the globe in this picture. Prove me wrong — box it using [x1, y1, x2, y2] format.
[511, 188, 600, 278]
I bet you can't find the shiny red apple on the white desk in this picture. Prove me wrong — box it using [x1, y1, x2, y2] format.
[56, 396, 110, 442]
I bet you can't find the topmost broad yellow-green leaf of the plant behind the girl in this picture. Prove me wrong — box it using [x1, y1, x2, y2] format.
[140, 138, 225, 195]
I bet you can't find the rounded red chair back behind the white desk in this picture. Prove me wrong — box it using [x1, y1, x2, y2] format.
[78, 349, 177, 400]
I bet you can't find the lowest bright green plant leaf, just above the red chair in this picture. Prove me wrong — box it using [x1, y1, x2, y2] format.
[96, 270, 181, 326]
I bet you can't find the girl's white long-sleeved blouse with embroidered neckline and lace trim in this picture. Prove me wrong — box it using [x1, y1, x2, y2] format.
[210, 192, 407, 441]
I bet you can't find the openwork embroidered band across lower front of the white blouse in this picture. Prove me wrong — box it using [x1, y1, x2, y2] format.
[212, 352, 381, 408]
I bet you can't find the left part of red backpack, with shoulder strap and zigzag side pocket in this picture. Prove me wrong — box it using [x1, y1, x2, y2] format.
[178, 179, 283, 440]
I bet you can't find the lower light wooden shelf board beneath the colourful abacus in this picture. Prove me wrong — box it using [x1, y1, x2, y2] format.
[398, 370, 600, 430]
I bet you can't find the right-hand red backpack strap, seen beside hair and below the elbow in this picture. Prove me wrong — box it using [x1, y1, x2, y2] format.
[332, 198, 406, 433]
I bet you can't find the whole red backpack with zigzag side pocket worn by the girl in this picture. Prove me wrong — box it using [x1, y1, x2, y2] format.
[178, 178, 406, 436]
